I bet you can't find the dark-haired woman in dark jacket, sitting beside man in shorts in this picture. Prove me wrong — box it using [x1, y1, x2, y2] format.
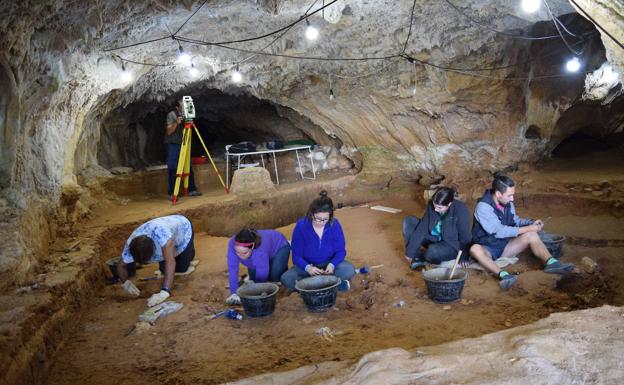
[403, 187, 471, 269]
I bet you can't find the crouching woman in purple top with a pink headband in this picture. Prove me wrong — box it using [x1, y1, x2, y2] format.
[225, 229, 290, 305]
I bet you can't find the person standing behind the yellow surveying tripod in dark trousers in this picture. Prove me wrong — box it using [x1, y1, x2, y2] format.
[164, 99, 201, 200]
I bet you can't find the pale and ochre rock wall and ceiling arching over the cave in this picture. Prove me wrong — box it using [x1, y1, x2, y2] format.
[0, 0, 623, 286]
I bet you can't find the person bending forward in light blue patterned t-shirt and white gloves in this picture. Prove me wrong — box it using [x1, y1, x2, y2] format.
[117, 215, 195, 306]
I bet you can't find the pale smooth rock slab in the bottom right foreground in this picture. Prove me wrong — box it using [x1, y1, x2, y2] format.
[234, 306, 624, 385]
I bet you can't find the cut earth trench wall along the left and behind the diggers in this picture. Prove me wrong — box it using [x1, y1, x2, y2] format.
[0, 176, 394, 385]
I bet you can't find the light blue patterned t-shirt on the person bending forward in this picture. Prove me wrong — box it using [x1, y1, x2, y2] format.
[121, 215, 193, 263]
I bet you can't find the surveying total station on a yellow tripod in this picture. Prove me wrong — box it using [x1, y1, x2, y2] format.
[171, 96, 229, 205]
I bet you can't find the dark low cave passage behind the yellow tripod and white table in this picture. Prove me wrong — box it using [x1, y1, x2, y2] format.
[97, 85, 353, 196]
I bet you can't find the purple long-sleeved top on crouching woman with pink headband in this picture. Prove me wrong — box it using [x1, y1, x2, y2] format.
[227, 230, 288, 294]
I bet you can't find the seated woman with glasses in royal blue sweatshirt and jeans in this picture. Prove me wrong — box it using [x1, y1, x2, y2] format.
[281, 191, 355, 291]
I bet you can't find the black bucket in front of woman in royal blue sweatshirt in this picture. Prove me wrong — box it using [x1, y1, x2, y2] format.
[295, 275, 342, 313]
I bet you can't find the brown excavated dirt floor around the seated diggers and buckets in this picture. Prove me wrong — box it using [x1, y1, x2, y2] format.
[40, 145, 624, 385]
